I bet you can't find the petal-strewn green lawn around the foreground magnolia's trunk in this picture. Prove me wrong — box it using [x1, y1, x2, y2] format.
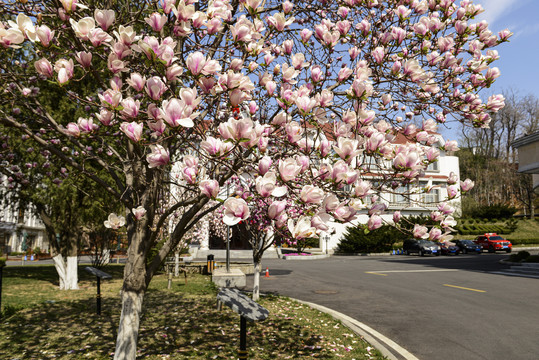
[0, 265, 383, 360]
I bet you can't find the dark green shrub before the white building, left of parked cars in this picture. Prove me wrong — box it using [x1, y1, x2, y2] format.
[337, 225, 409, 254]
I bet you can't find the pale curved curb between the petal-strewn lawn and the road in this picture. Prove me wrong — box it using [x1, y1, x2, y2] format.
[290, 298, 419, 360]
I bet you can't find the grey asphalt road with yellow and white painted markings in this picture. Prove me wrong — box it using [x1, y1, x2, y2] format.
[251, 253, 539, 360]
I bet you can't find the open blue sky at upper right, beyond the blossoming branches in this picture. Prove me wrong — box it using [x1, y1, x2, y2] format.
[440, 0, 539, 140]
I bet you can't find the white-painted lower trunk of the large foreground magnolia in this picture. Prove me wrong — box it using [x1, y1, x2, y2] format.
[114, 290, 144, 360]
